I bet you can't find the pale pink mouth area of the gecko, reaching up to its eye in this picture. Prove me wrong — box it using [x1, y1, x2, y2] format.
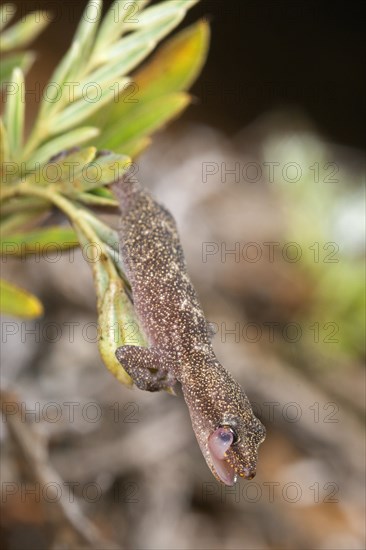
[208, 428, 238, 485]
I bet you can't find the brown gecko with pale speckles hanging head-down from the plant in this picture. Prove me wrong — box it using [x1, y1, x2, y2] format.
[112, 171, 266, 486]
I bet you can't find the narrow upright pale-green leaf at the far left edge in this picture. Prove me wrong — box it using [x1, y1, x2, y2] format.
[4, 68, 25, 158]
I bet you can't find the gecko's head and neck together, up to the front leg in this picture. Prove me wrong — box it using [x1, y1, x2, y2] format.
[182, 368, 266, 485]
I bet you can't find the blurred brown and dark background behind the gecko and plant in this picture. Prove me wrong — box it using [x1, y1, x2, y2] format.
[1, 0, 365, 550]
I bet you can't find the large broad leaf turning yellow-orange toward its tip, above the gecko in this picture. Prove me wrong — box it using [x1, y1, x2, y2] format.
[92, 22, 209, 154]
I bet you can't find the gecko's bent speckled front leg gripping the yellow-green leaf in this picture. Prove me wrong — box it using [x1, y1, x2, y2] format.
[116, 346, 176, 392]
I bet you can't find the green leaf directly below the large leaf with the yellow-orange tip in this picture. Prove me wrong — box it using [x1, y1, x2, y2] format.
[98, 93, 190, 152]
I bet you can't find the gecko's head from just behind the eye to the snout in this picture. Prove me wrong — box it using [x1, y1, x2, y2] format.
[205, 414, 266, 485]
